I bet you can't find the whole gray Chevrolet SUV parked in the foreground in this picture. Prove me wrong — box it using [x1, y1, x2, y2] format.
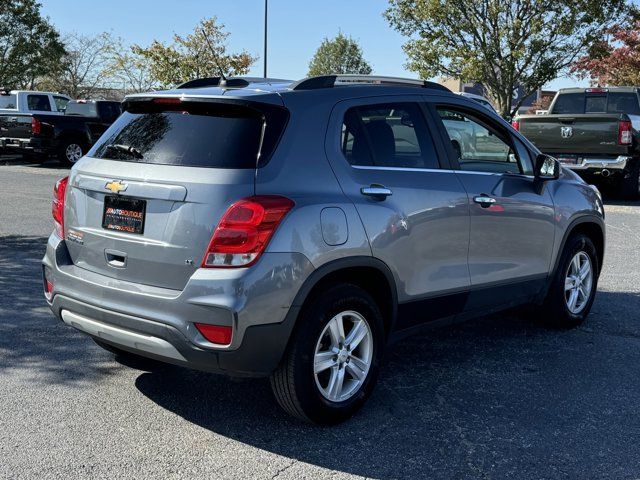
[43, 75, 605, 424]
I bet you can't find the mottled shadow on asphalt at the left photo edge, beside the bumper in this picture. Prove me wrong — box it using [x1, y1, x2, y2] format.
[0, 236, 122, 384]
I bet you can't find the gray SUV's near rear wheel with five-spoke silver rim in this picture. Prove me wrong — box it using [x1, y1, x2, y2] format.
[271, 284, 385, 425]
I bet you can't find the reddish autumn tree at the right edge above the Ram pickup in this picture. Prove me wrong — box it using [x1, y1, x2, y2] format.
[573, 20, 640, 86]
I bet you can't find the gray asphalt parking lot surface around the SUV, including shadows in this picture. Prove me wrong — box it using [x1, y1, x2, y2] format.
[0, 160, 640, 479]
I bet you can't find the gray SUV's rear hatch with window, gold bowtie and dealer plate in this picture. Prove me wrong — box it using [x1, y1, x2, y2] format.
[65, 97, 286, 290]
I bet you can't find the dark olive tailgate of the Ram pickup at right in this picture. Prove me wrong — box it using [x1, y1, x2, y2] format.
[520, 114, 628, 155]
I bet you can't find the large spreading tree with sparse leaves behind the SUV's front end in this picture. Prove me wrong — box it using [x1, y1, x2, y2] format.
[384, 0, 628, 117]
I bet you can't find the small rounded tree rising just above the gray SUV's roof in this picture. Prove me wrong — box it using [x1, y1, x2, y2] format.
[308, 32, 371, 77]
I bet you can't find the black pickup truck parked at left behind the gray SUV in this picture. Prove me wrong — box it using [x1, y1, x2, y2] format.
[0, 100, 121, 166]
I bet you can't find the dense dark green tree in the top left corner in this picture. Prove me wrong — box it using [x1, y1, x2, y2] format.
[0, 0, 65, 88]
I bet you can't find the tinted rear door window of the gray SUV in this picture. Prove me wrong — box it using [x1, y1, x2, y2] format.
[341, 103, 439, 168]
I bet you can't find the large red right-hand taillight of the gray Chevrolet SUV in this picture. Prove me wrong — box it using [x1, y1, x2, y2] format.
[202, 195, 294, 268]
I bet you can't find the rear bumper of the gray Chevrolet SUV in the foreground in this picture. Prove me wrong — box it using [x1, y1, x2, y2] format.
[43, 235, 312, 376]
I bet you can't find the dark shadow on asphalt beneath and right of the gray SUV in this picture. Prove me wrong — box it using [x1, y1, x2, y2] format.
[136, 292, 640, 479]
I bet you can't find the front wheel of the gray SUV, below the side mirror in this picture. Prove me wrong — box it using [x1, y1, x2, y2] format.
[537, 234, 600, 328]
